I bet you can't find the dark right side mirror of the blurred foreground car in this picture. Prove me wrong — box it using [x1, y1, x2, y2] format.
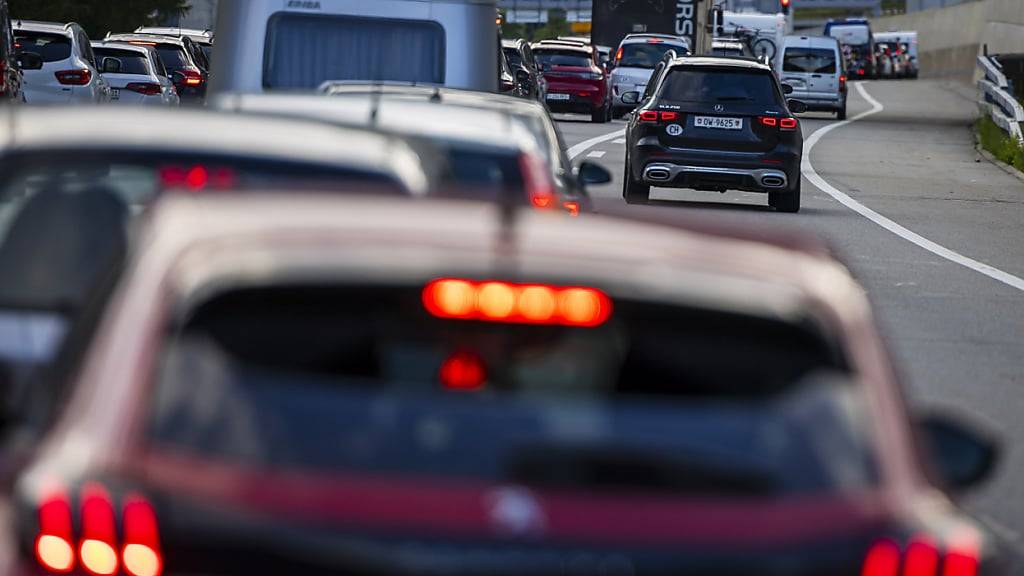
[918, 414, 999, 490]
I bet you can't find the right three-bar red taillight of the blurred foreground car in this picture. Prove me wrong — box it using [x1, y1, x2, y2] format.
[860, 536, 980, 576]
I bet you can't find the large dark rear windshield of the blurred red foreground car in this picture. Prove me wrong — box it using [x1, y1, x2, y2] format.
[147, 283, 874, 497]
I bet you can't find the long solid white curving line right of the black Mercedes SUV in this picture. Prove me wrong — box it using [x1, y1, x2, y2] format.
[801, 82, 1024, 292]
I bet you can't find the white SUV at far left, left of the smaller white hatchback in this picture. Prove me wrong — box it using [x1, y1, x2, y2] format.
[13, 20, 111, 104]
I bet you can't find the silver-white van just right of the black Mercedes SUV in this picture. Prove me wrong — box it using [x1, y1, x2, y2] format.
[781, 36, 847, 120]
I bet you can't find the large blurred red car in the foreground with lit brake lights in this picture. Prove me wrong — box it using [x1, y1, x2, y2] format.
[0, 195, 1004, 576]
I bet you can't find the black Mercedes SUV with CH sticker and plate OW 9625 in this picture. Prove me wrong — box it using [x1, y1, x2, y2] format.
[623, 56, 806, 212]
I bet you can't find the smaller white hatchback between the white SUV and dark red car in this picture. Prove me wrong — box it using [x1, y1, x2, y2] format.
[92, 42, 181, 106]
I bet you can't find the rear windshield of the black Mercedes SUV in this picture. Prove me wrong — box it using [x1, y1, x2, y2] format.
[660, 68, 778, 106]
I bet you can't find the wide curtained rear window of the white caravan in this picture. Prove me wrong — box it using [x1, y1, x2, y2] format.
[263, 12, 445, 89]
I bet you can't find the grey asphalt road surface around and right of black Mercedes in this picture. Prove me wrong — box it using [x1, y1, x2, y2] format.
[557, 80, 1024, 546]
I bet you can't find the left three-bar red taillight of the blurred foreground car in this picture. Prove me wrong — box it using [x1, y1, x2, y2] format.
[35, 484, 163, 576]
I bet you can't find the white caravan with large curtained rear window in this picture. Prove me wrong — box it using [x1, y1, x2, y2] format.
[210, 0, 499, 94]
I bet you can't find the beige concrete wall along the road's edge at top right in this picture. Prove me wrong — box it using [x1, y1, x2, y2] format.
[871, 0, 1024, 83]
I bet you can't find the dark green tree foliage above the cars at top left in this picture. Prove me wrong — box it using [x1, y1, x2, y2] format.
[10, 0, 190, 39]
